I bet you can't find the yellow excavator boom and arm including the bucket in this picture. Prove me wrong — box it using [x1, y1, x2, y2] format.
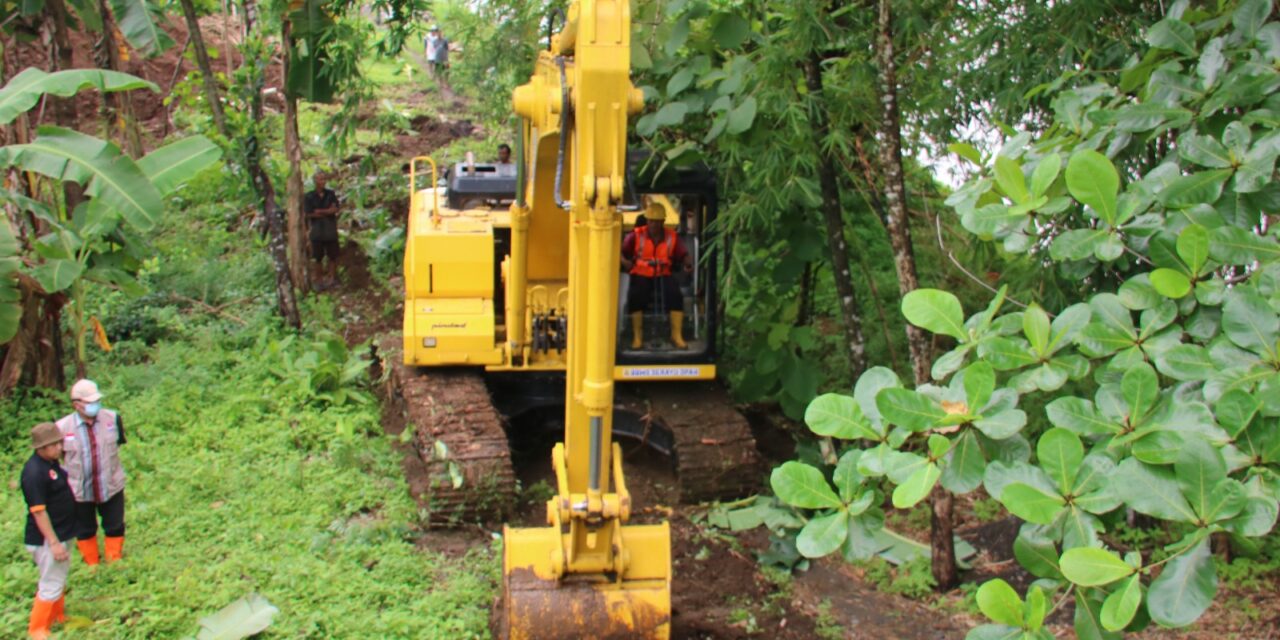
[500, 0, 671, 639]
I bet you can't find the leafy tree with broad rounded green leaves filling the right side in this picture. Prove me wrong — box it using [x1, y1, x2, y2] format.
[774, 0, 1280, 639]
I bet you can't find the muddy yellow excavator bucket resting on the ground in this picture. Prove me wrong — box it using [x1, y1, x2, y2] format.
[500, 522, 671, 640]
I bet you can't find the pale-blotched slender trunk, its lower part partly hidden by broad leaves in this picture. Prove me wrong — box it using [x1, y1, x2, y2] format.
[876, 0, 960, 589]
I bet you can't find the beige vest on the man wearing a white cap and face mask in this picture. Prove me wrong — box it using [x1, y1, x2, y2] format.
[58, 408, 124, 502]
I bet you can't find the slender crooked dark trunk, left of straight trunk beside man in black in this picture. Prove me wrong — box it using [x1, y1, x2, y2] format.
[244, 0, 302, 330]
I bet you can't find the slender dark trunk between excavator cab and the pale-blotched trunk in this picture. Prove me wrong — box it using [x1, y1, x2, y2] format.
[804, 51, 867, 379]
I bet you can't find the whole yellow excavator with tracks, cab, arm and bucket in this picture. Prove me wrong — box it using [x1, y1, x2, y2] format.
[392, 0, 763, 639]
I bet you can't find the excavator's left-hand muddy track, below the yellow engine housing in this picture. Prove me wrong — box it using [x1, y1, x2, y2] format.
[384, 349, 517, 526]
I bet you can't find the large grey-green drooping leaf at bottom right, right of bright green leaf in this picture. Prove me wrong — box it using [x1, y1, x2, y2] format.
[1147, 538, 1217, 627]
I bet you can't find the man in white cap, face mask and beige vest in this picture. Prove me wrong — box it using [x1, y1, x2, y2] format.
[58, 380, 125, 566]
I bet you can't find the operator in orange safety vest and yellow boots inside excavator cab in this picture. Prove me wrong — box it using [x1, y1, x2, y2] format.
[622, 202, 694, 349]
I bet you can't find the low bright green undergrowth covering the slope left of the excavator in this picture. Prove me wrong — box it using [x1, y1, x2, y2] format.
[0, 172, 498, 639]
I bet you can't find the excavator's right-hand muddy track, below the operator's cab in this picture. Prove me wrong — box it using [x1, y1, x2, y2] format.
[614, 381, 764, 503]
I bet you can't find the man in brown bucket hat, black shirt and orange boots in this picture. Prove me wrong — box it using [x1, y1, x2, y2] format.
[22, 422, 76, 640]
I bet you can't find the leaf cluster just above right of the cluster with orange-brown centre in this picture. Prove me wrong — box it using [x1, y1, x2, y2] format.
[978, 302, 1093, 393]
